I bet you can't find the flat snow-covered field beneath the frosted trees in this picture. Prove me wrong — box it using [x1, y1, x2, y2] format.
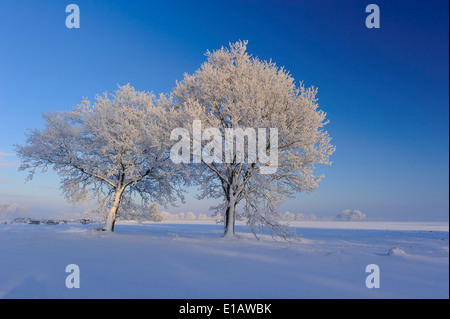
[0, 221, 449, 299]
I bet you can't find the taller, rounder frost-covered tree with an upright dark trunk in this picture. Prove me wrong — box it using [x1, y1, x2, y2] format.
[172, 41, 334, 237]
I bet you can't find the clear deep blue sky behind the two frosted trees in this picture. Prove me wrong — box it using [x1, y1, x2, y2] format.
[0, 0, 449, 221]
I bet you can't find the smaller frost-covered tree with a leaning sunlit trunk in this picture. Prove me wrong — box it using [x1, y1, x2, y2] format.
[16, 84, 183, 231]
